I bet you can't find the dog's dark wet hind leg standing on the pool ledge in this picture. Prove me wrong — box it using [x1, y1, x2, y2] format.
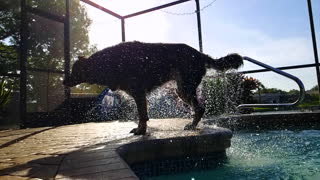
[177, 78, 205, 130]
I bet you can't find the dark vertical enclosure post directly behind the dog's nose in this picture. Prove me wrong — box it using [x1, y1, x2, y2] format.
[64, 0, 70, 100]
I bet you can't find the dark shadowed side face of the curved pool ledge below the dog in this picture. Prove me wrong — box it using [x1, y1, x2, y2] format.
[116, 128, 232, 178]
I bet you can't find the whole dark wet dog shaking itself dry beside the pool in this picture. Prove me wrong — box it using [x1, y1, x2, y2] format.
[64, 41, 243, 135]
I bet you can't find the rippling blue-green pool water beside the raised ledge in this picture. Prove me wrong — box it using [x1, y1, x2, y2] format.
[147, 130, 320, 180]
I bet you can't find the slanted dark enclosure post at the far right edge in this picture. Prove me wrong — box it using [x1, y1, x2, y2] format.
[307, 0, 320, 101]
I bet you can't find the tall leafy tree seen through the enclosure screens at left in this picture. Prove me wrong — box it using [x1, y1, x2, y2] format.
[0, 0, 96, 111]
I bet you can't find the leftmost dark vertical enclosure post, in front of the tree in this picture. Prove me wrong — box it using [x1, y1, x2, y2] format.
[20, 0, 28, 127]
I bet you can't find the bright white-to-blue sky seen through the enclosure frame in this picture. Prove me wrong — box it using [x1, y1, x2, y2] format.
[83, 0, 320, 90]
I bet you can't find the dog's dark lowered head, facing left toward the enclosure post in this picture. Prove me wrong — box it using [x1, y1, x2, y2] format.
[63, 56, 88, 87]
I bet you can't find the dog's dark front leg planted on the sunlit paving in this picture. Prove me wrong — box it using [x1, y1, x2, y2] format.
[130, 92, 149, 135]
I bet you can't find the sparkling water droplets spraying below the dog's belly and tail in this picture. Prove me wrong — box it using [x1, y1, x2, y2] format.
[82, 71, 250, 121]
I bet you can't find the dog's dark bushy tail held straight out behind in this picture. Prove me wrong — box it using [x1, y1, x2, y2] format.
[206, 53, 243, 71]
